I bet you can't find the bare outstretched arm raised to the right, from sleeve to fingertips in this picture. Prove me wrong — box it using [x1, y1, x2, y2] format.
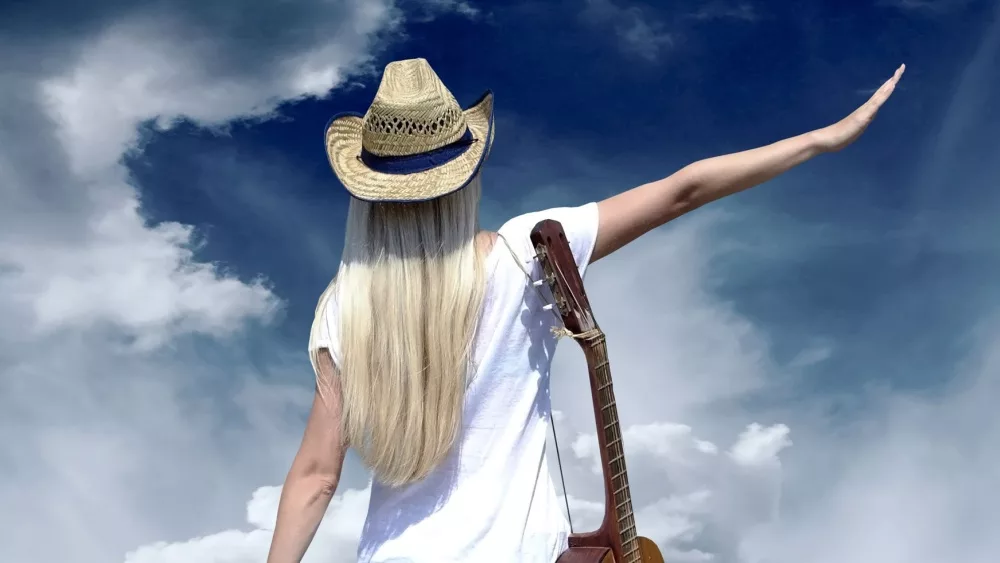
[591, 65, 906, 262]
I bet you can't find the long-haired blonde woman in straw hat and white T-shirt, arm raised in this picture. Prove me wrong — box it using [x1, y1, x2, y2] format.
[268, 59, 904, 563]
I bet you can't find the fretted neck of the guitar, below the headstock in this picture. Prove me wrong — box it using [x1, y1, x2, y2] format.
[580, 330, 639, 561]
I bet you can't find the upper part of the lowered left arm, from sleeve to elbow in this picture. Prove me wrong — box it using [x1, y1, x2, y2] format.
[292, 348, 347, 484]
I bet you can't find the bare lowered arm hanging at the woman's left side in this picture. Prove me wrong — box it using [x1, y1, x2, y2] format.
[267, 349, 347, 563]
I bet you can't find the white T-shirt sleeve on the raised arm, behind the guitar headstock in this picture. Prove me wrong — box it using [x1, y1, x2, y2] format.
[500, 202, 598, 277]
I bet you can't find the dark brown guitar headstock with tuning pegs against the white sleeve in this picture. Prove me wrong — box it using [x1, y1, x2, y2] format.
[531, 219, 597, 334]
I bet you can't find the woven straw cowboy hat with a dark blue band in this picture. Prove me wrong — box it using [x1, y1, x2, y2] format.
[326, 59, 493, 202]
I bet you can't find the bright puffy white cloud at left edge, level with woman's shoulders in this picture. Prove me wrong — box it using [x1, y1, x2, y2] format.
[2, 199, 279, 348]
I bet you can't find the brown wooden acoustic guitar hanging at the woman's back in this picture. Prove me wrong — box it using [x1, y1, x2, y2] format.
[531, 219, 663, 563]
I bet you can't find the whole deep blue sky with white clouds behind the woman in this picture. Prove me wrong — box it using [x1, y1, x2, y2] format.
[0, 0, 1000, 563]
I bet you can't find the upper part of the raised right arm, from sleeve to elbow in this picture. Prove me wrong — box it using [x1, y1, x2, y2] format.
[590, 170, 695, 262]
